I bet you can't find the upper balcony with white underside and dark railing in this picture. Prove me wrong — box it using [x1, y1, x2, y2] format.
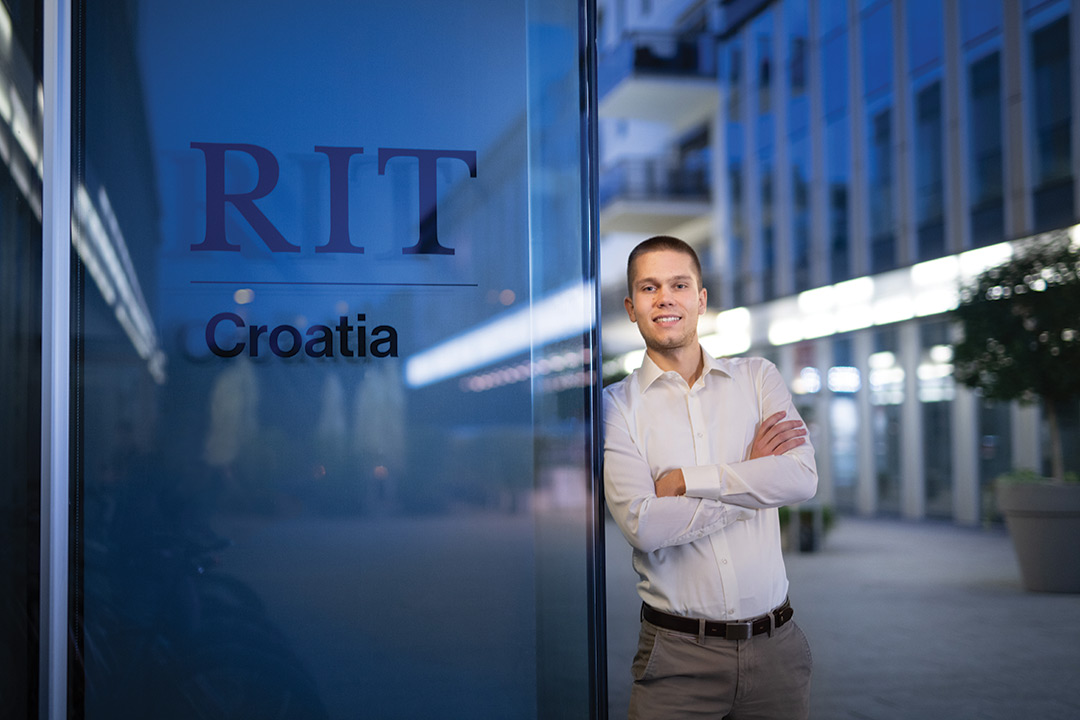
[597, 32, 719, 133]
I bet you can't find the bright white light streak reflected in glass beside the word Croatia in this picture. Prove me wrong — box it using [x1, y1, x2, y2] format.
[405, 283, 593, 389]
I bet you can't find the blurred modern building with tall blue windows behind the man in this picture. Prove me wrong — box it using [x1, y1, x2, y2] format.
[599, 0, 1080, 524]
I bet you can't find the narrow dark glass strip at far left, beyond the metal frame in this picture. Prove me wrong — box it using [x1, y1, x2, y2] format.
[0, 2, 43, 718]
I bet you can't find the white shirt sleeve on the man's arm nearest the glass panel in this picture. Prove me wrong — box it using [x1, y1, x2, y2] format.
[604, 394, 755, 553]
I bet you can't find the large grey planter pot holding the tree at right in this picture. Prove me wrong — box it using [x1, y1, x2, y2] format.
[998, 483, 1080, 593]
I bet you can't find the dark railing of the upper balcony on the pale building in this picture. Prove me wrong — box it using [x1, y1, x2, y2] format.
[597, 32, 716, 97]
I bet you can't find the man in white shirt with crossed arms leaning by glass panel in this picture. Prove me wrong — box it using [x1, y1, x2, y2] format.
[604, 236, 818, 720]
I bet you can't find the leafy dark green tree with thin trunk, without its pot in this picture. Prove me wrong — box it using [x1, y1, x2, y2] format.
[953, 231, 1080, 481]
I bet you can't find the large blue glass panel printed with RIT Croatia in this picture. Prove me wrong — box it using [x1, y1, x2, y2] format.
[73, 0, 602, 720]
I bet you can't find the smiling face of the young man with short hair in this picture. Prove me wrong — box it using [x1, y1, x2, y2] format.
[624, 250, 705, 352]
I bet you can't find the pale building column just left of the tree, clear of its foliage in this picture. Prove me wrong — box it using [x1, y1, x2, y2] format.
[897, 321, 927, 519]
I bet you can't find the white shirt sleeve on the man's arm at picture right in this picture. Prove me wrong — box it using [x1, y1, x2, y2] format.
[683, 361, 818, 510]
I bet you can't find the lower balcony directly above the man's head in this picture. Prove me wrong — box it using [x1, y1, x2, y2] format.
[599, 158, 711, 235]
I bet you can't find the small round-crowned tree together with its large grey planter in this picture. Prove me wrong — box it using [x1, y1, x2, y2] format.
[953, 232, 1080, 593]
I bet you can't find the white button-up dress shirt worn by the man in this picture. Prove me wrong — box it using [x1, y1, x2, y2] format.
[604, 350, 818, 621]
